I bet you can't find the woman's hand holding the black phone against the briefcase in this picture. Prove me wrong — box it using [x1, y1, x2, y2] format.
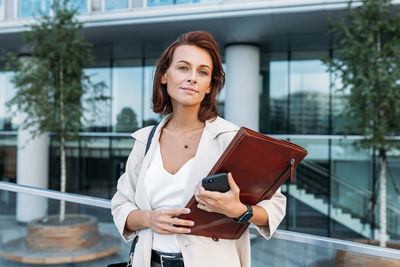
[195, 173, 247, 218]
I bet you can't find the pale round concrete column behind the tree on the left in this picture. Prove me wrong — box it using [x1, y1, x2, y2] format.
[16, 58, 49, 223]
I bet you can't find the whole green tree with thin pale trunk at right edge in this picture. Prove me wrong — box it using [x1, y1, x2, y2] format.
[325, 0, 400, 246]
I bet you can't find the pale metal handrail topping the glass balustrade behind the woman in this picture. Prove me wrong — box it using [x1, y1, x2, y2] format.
[0, 181, 400, 260]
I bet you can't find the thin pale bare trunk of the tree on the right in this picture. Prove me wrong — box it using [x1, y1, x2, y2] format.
[379, 149, 387, 247]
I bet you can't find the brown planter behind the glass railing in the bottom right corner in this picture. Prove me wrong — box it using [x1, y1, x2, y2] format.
[335, 240, 400, 267]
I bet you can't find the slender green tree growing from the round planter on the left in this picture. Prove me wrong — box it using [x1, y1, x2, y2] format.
[3, 0, 109, 221]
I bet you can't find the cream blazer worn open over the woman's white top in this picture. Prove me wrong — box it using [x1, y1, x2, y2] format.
[111, 116, 286, 267]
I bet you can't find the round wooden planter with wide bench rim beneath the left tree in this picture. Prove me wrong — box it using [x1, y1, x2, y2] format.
[0, 214, 121, 264]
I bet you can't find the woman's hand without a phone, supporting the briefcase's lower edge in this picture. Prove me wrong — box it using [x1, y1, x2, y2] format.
[148, 208, 194, 235]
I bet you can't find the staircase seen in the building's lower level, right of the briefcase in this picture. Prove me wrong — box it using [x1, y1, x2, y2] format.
[288, 161, 400, 243]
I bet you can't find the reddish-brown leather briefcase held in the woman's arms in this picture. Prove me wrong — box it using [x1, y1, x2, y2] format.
[180, 127, 307, 239]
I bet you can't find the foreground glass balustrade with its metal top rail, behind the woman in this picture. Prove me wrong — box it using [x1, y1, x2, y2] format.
[0, 182, 400, 267]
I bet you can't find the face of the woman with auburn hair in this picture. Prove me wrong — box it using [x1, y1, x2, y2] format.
[161, 45, 213, 107]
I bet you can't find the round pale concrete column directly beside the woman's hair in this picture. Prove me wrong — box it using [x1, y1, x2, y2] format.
[225, 44, 260, 131]
